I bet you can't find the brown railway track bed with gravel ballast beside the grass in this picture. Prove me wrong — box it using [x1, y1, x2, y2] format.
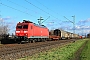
[0, 40, 76, 60]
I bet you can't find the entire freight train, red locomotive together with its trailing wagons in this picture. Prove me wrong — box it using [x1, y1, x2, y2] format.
[15, 20, 79, 43]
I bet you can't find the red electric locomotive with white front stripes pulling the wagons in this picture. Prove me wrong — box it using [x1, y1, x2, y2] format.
[15, 20, 49, 43]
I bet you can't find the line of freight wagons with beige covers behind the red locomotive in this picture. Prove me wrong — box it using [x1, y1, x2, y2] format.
[50, 29, 79, 40]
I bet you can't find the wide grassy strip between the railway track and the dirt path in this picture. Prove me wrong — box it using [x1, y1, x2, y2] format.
[18, 39, 86, 60]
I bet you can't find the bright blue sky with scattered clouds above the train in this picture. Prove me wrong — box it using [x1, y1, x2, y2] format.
[0, 0, 90, 35]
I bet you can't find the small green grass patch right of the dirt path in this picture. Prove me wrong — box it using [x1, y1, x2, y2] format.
[80, 39, 90, 60]
